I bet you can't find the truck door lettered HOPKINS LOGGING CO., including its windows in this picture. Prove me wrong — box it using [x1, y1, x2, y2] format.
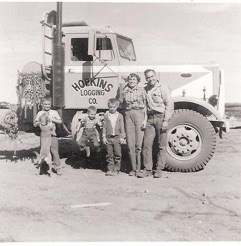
[65, 33, 119, 109]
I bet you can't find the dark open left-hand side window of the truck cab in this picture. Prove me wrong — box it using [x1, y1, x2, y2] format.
[71, 38, 93, 61]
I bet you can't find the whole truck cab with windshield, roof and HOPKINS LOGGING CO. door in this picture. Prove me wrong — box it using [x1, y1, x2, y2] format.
[63, 26, 136, 110]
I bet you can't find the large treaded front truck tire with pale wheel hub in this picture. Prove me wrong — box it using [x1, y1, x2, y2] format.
[166, 109, 216, 172]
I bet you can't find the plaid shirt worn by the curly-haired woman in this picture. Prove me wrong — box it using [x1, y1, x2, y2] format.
[119, 85, 146, 110]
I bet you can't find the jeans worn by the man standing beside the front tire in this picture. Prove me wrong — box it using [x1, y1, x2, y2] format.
[143, 114, 167, 170]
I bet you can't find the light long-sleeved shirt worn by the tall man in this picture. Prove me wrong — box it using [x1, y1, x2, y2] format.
[145, 83, 174, 121]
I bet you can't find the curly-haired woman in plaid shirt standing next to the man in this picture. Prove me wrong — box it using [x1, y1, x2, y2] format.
[119, 73, 147, 176]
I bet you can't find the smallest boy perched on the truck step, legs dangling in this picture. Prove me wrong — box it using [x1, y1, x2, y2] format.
[78, 106, 101, 157]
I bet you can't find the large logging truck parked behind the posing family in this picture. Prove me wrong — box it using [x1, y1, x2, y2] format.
[18, 4, 229, 172]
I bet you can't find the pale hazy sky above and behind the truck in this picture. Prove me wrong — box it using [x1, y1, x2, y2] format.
[0, 2, 241, 103]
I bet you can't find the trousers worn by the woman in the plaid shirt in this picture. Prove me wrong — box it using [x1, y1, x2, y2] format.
[125, 109, 145, 171]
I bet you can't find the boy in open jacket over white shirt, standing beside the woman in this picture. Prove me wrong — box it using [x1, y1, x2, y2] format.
[103, 98, 126, 176]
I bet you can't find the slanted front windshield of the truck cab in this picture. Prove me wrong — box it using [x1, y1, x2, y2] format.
[117, 36, 136, 61]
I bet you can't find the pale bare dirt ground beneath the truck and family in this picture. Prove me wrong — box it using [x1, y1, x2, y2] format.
[0, 129, 241, 242]
